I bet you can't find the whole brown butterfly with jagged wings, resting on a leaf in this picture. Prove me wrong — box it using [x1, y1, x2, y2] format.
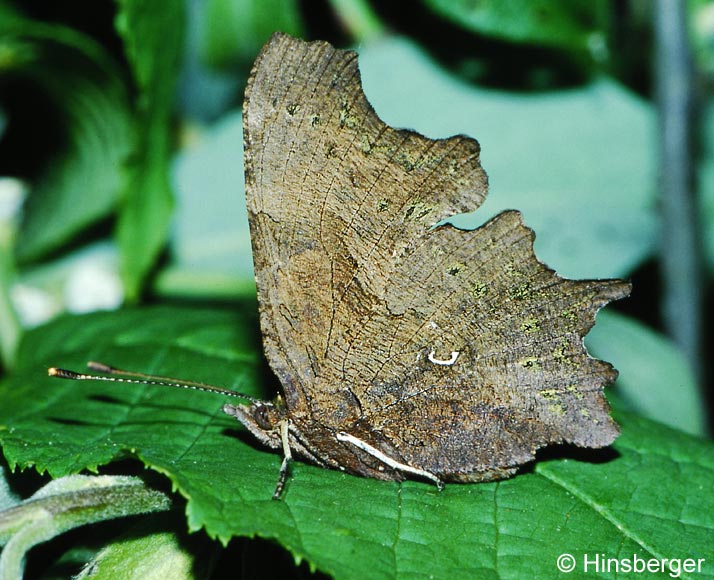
[51, 34, 630, 498]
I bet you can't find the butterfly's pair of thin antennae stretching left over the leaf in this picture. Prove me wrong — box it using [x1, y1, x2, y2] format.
[47, 361, 259, 403]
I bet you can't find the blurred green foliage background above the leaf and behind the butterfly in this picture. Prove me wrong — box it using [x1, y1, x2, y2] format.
[0, 0, 714, 576]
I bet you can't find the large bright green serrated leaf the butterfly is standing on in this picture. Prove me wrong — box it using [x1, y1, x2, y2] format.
[0, 305, 714, 579]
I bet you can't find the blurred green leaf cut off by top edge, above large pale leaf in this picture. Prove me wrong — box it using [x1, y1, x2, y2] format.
[424, 0, 607, 50]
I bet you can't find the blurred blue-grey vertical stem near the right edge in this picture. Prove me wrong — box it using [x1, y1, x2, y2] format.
[654, 0, 703, 385]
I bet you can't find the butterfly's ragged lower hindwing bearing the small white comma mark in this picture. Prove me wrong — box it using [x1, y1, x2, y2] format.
[357, 212, 628, 479]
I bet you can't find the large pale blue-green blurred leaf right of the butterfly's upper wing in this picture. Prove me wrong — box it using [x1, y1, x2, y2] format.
[360, 38, 658, 278]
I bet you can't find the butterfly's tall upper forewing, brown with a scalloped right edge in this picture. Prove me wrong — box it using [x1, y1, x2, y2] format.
[244, 35, 486, 412]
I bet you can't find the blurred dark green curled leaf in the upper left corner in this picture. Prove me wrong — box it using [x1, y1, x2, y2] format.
[0, 20, 133, 261]
